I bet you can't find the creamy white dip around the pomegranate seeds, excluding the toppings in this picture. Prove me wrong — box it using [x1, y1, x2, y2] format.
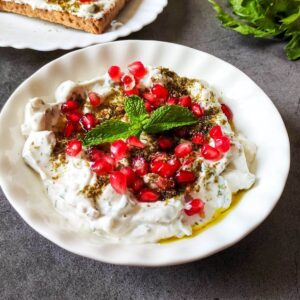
[22, 67, 256, 243]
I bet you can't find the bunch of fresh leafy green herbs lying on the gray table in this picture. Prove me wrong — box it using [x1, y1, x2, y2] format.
[208, 0, 300, 60]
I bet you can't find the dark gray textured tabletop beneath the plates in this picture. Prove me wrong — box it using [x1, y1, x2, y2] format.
[0, 0, 300, 299]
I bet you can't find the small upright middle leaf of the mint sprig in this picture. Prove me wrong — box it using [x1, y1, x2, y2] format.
[125, 96, 148, 122]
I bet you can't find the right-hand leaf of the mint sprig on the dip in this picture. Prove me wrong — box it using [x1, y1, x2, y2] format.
[143, 105, 197, 133]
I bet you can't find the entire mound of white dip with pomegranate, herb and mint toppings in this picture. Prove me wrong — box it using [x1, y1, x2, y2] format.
[22, 62, 256, 243]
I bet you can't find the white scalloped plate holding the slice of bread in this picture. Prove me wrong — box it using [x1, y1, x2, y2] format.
[0, 0, 168, 51]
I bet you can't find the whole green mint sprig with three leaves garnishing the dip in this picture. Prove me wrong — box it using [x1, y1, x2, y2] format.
[83, 96, 197, 146]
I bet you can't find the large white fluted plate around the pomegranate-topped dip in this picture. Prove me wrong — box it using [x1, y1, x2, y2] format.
[0, 41, 290, 266]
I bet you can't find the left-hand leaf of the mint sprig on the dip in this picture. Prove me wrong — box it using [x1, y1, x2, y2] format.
[83, 120, 140, 146]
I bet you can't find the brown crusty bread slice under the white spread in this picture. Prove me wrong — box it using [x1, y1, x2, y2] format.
[0, 0, 126, 34]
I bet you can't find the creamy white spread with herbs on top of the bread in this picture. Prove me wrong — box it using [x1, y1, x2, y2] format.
[4, 0, 116, 19]
